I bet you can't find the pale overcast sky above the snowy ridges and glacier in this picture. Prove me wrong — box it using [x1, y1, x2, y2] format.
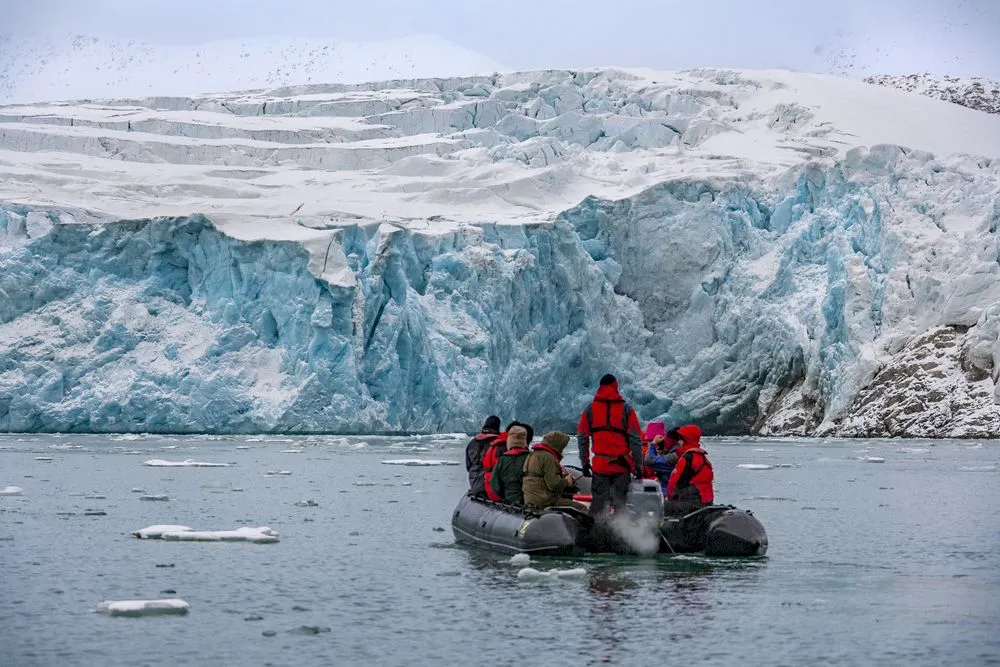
[0, 0, 1000, 79]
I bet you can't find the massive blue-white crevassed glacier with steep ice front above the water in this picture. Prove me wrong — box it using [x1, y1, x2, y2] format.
[0, 69, 1000, 437]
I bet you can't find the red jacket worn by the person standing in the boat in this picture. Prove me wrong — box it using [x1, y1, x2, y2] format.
[576, 382, 642, 475]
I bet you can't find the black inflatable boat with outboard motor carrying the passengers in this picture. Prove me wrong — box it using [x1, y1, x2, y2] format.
[451, 482, 767, 556]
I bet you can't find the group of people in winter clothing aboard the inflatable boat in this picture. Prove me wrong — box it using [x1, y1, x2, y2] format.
[465, 374, 714, 518]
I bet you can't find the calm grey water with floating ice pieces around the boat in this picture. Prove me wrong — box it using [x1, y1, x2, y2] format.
[0, 436, 1000, 667]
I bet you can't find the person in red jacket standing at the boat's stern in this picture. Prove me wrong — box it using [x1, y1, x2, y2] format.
[576, 374, 642, 518]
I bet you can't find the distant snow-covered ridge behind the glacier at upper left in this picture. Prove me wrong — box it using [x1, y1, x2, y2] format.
[0, 35, 504, 104]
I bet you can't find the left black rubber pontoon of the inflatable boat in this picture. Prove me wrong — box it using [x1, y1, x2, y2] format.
[451, 495, 590, 556]
